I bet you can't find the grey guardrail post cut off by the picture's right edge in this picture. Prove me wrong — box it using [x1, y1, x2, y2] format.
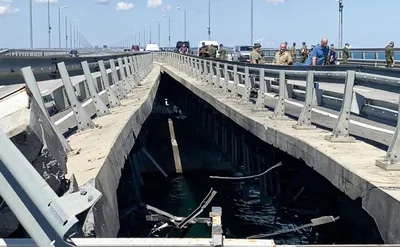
[375, 100, 400, 171]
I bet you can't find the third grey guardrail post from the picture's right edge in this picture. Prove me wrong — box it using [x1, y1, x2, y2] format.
[293, 71, 315, 130]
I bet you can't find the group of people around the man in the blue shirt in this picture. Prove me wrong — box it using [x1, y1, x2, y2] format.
[250, 38, 350, 66]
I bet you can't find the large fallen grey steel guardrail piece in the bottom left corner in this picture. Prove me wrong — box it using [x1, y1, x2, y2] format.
[0, 130, 101, 246]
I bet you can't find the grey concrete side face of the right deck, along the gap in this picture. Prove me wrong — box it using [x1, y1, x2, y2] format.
[161, 65, 400, 243]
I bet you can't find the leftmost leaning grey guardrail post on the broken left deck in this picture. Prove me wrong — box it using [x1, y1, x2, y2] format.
[21, 66, 72, 154]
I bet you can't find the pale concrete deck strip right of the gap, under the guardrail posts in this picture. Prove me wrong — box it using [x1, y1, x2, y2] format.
[162, 61, 400, 243]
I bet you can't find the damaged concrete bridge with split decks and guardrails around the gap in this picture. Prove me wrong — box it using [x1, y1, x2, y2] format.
[0, 51, 400, 246]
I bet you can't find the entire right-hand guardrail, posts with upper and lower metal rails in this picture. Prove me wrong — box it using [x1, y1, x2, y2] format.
[153, 52, 400, 173]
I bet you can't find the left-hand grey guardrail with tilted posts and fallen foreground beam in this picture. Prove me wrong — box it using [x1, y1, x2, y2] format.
[0, 51, 153, 246]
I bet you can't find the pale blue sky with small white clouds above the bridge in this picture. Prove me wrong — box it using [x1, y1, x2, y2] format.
[0, 0, 400, 48]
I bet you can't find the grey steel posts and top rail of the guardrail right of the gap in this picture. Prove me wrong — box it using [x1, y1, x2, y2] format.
[154, 52, 400, 170]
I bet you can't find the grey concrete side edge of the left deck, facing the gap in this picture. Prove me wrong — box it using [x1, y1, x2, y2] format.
[93, 66, 161, 238]
